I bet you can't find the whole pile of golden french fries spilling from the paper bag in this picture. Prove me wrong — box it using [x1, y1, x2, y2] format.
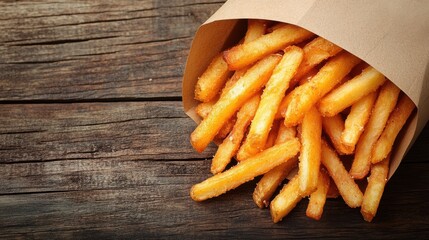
[190, 20, 415, 222]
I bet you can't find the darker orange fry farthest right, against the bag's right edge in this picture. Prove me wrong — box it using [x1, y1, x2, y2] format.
[371, 94, 415, 164]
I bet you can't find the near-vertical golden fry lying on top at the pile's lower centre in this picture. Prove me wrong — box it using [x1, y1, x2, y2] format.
[298, 107, 322, 196]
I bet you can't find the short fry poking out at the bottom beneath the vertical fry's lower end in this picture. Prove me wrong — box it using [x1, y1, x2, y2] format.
[305, 169, 331, 220]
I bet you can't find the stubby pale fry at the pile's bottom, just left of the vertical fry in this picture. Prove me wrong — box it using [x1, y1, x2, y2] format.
[270, 174, 302, 223]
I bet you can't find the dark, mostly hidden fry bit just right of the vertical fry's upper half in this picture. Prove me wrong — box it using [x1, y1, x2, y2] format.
[322, 114, 353, 155]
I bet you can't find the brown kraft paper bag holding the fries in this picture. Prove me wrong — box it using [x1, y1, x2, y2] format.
[182, 0, 429, 178]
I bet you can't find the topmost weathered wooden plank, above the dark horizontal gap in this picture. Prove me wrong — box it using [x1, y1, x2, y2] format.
[0, 0, 224, 101]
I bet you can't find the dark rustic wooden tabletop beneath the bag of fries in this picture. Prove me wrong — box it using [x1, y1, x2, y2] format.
[0, 0, 429, 239]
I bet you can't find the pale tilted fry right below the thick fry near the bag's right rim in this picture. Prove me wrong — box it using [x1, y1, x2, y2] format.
[341, 92, 377, 151]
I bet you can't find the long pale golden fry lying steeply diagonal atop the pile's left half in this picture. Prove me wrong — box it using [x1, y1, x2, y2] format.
[237, 46, 304, 160]
